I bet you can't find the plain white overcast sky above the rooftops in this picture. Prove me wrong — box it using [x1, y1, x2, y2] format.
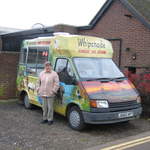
[0, 0, 106, 29]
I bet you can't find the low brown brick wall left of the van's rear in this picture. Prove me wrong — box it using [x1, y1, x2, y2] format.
[0, 52, 19, 100]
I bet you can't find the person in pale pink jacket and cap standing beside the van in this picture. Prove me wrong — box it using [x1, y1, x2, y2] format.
[37, 62, 59, 125]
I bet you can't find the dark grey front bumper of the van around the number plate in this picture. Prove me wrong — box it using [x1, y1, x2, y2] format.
[82, 107, 142, 124]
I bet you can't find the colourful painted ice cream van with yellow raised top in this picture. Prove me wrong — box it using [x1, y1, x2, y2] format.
[17, 34, 142, 130]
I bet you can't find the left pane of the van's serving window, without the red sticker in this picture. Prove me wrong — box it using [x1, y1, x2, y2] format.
[27, 48, 37, 75]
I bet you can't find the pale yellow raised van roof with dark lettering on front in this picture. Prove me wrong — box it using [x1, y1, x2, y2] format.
[23, 34, 113, 58]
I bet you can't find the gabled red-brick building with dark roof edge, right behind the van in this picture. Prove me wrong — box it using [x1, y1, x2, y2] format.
[79, 0, 150, 73]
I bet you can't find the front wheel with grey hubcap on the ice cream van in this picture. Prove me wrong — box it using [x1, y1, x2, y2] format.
[67, 106, 85, 131]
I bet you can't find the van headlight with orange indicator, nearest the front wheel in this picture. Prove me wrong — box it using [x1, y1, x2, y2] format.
[90, 100, 109, 108]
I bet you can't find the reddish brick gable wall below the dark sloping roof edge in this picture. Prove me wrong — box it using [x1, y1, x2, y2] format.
[79, 0, 150, 70]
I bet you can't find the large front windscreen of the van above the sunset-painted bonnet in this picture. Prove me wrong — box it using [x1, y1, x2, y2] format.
[73, 58, 124, 79]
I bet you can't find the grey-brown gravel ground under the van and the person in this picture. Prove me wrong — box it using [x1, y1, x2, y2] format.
[0, 101, 150, 150]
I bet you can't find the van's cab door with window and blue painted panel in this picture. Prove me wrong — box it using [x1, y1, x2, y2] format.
[54, 58, 75, 115]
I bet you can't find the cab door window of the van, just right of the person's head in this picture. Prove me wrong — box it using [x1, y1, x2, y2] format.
[55, 58, 73, 85]
